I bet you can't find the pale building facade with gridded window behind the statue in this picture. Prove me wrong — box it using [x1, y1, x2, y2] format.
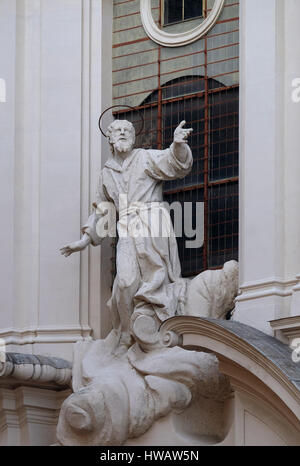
[0, 0, 300, 445]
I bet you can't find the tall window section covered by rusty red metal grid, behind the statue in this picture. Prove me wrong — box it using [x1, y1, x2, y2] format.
[113, 0, 239, 276]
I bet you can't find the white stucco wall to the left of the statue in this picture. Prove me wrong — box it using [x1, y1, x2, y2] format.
[0, 0, 112, 359]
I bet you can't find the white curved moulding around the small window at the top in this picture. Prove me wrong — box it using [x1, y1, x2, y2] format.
[140, 0, 225, 47]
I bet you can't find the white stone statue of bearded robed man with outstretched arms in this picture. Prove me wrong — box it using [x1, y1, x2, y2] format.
[61, 120, 193, 351]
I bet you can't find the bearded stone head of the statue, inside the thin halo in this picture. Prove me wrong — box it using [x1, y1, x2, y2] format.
[106, 120, 135, 156]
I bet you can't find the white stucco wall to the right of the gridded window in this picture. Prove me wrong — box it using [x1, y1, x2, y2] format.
[235, 0, 300, 333]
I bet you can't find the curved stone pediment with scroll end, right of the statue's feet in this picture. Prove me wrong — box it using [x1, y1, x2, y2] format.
[160, 316, 300, 427]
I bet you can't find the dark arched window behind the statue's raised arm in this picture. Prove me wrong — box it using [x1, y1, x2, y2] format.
[116, 76, 239, 276]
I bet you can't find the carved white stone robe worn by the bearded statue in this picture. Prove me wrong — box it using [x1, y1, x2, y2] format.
[83, 144, 193, 345]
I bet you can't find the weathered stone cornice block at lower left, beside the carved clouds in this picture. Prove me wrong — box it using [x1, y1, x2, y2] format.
[0, 348, 72, 446]
